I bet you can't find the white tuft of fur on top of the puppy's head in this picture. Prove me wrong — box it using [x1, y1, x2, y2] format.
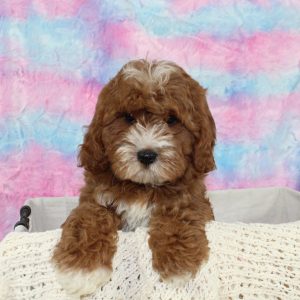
[122, 60, 177, 88]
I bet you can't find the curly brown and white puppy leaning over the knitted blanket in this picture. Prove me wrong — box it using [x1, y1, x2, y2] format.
[53, 60, 216, 295]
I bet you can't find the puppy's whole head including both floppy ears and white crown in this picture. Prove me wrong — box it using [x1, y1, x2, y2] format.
[79, 60, 215, 185]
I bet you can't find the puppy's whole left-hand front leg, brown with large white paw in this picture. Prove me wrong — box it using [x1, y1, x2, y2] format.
[52, 202, 119, 296]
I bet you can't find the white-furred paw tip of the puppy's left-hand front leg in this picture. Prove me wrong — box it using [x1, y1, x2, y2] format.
[55, 267, 112, 296]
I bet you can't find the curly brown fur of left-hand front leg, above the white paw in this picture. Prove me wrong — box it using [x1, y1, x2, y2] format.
[53, 203, 119, 271]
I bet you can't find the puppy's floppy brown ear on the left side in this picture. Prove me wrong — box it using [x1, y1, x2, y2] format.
[78, 92, 108, 174]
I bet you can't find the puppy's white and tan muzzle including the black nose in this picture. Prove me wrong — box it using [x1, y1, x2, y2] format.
[112, 127, 184, 186]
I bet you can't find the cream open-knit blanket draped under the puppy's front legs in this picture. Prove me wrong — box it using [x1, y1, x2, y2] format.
[0, 222, 300, 300]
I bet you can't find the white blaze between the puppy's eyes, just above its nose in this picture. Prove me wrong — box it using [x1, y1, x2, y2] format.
[123, 123, 174, 151]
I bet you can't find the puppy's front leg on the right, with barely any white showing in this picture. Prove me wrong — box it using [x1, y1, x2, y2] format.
[149, 199, 213, 286]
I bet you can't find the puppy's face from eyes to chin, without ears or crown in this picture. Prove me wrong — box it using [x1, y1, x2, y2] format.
[102, 108, 193, 185]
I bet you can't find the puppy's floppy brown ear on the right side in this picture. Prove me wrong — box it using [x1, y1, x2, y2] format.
[190, 80, 216, 174]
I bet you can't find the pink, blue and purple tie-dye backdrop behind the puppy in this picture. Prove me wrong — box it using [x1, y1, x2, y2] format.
[0, 0, 300, 236]
